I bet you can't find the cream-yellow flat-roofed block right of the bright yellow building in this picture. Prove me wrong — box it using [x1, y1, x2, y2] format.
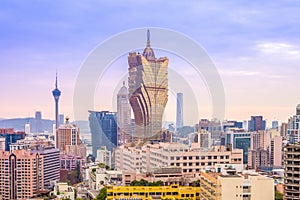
[200, 170, 274, 200]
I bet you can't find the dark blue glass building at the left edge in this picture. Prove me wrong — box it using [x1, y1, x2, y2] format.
[0, 128, 25, 151]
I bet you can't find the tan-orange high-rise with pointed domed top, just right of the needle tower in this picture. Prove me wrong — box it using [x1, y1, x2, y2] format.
[56, 117, 80, 153]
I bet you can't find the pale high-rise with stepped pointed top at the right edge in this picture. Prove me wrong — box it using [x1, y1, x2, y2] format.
[286, 104, 300, 143]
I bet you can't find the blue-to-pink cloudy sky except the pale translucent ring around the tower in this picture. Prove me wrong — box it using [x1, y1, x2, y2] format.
[0, 0, 300, 125]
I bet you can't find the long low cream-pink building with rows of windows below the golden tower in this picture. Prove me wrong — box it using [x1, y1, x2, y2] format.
[115, 143, 243, 175]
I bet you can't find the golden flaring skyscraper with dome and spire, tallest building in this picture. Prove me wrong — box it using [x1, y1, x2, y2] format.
[128, 30, 169, 141]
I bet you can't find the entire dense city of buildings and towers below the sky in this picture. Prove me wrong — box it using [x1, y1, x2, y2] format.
[0, 31, 300, 200]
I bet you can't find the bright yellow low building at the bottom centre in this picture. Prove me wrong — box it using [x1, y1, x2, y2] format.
[107, 185, 200, 200]
